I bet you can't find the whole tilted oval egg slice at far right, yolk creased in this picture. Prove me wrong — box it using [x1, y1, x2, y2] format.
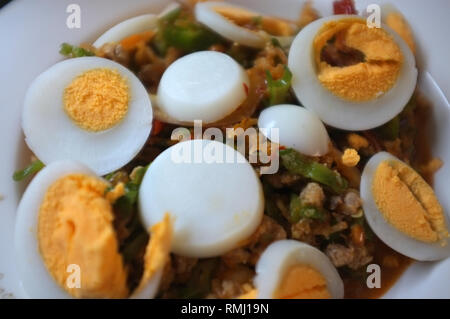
[360, 152, 450, 260]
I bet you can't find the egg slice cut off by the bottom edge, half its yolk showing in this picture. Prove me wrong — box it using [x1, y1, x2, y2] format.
[254, 240, 344, 299]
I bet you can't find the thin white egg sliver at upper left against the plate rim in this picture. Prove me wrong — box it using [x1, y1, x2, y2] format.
[93, 14, 158, 48]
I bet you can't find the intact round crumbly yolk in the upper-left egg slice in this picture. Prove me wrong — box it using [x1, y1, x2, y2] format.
[63, 68, 130, 132]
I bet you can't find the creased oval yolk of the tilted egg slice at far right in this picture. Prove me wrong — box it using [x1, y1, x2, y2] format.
[372, 161, 449, 245]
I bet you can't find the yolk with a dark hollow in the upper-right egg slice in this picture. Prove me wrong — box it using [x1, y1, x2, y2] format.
[313, 18, 403, 102]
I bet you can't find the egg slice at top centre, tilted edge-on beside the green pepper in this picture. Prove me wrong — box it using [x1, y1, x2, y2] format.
[195, 1, 296, 48]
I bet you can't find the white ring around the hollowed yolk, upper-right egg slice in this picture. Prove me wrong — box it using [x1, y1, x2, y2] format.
[288, 15, 417, 131]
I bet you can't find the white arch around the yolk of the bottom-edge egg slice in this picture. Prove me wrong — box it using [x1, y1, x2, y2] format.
[254, 240, 344, 299]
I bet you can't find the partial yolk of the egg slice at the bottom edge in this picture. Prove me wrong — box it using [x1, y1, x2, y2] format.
[274, 265, 331, 299]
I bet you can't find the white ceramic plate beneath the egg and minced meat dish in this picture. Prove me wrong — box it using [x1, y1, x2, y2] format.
[0, 0, 450, 298]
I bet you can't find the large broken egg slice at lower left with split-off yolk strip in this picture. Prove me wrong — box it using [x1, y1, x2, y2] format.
[14, 161, 172, 298]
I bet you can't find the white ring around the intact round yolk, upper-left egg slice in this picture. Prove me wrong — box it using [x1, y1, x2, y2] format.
[22, 57, 153, 175]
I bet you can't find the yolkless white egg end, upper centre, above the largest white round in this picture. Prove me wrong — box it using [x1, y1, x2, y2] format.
[157, 51, 249, 123]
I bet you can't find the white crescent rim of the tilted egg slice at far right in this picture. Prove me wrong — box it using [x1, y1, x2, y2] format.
[360, 152, 450, 261]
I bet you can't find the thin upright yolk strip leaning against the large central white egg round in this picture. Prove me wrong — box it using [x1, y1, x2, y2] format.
[136, 213, 173, 292]
